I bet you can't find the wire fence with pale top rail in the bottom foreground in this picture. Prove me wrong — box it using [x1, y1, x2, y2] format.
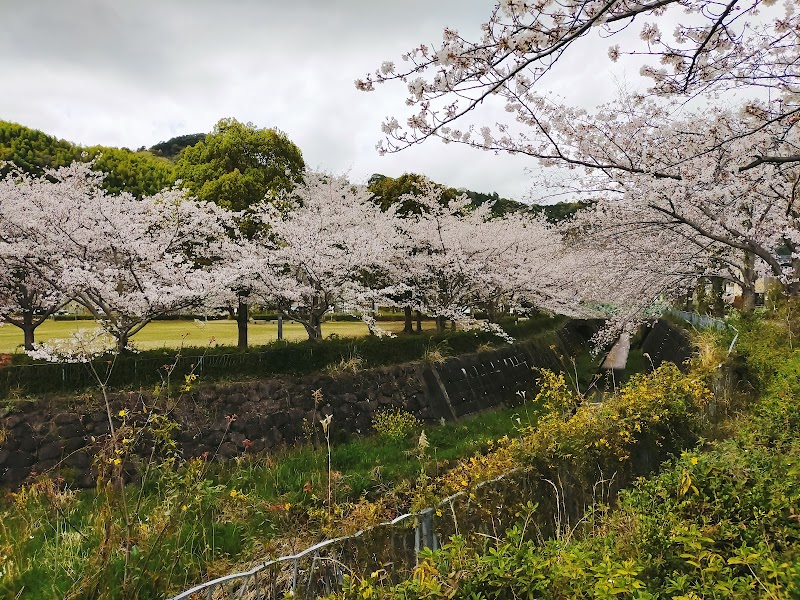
[171, 469, 546, 600]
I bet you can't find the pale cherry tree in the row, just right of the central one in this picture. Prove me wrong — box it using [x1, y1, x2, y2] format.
[394, 181, 561, 330]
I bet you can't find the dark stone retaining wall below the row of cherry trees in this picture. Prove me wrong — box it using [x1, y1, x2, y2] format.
[0, 321, 598, 487]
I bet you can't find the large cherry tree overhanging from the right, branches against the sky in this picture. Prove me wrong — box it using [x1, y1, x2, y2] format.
[356, 0, 800, 328]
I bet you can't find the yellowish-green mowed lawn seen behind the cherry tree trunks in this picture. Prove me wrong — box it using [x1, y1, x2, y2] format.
[0, 320, 435, 352]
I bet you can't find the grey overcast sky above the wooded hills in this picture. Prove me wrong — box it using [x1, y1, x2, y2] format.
[0, 0, 640, 199]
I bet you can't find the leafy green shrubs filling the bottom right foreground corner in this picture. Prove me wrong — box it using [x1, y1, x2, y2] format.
[338, 442, 800, 600]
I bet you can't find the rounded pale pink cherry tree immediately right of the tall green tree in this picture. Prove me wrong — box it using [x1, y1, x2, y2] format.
[245, 172, 406, 340]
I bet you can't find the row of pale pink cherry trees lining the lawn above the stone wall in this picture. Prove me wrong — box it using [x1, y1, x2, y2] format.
[0, 163, 600, 348]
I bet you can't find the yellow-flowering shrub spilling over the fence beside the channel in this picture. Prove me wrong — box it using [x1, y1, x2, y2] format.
[414, 363, 711, 507]
